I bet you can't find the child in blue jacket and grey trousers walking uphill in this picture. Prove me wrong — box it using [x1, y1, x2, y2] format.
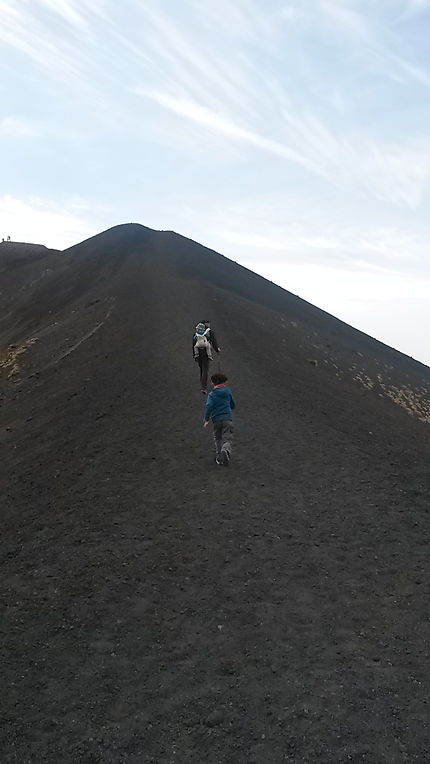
[203, 372, 236, 467]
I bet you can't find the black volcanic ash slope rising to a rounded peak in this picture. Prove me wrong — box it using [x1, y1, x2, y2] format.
[0, 225, 430, 764]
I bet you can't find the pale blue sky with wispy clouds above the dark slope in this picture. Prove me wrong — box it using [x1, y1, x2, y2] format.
[0, 0, 430, 365]
